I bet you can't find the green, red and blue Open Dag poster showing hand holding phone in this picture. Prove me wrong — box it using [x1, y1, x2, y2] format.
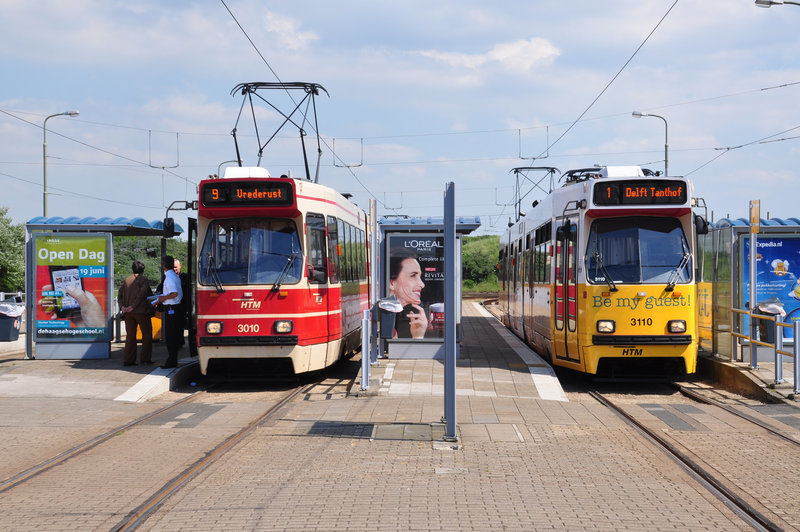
[34, 234, 111, 342]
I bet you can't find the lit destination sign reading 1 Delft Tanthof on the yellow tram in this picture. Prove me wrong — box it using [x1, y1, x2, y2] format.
[594, 179, 686, 205]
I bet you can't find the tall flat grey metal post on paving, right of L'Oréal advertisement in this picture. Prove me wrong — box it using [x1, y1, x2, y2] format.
[444, 181, 458, 441]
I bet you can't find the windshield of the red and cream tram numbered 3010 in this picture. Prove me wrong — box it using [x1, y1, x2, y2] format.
[198, 218, 303, 286]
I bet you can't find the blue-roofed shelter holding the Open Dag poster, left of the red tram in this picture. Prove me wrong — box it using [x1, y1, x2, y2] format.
[25, 216, 186, 359]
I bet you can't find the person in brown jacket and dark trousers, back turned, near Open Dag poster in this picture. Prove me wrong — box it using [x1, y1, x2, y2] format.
[117, 260, 153, 366]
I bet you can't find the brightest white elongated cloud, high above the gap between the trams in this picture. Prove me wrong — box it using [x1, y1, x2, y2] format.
[418, 37, 561, 72]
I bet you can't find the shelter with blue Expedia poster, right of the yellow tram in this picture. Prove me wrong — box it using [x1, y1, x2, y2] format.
[697, 218, 800, 360]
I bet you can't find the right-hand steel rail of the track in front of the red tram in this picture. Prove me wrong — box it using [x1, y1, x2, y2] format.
[111, 383, 316, 532]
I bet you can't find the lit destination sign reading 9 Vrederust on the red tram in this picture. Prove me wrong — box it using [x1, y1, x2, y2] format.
[202, 180, 294, 207]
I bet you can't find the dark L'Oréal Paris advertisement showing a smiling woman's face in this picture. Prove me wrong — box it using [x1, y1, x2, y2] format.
[384, 234, 445, 339]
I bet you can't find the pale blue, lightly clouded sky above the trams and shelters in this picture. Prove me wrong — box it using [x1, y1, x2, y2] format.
[0, 0, 800, 234]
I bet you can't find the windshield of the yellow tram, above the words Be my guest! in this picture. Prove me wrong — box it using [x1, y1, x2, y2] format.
[586, 216, 692, 284]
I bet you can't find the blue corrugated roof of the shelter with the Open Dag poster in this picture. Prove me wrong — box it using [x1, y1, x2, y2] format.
[25, 216, 183, 236]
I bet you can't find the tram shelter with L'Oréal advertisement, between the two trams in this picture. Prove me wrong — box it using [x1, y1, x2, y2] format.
[378, 216, 481, 359]
